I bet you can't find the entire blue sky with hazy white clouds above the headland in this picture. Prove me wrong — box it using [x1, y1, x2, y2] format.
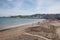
[0, 0, 60, 16]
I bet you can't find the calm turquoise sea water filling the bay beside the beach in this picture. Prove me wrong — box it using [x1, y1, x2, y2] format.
[0, 18, 43, 29]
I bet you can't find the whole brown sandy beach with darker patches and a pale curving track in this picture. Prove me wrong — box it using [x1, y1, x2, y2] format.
[0, 20, 60, 40]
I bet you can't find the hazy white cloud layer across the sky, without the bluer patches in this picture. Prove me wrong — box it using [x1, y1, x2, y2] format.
[0, 0, 60, 16]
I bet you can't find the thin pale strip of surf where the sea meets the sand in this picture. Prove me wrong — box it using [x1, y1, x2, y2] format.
[0, 19, 45, 31]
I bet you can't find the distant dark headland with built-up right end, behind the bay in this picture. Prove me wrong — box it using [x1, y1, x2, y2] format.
[6, 14, 60, 19]
